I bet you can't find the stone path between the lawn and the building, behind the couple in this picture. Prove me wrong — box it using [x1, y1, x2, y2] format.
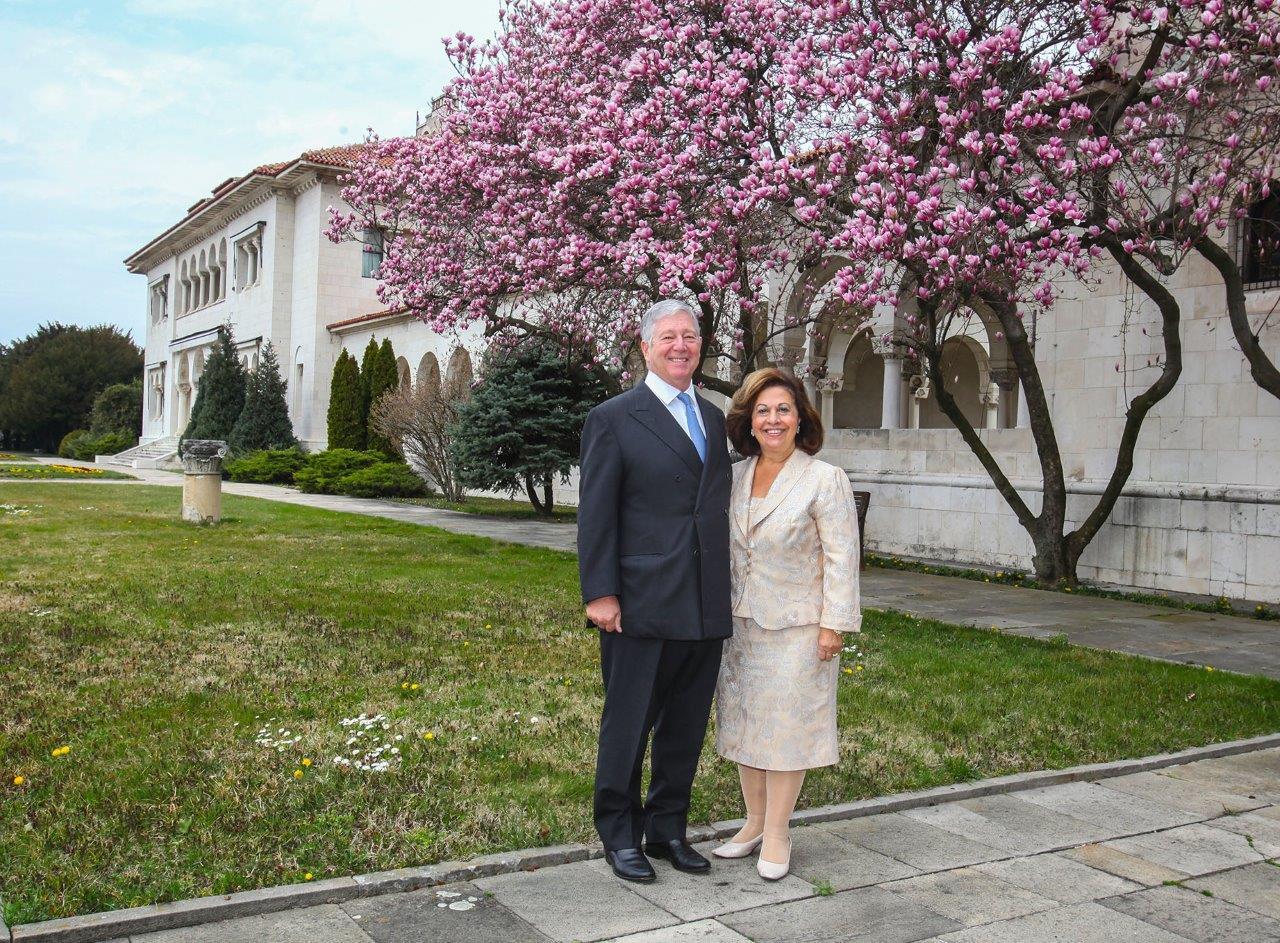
[17, 459, 1280, 678]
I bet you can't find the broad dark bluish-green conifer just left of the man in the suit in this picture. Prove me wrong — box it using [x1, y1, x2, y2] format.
[451, 340, 605, 514]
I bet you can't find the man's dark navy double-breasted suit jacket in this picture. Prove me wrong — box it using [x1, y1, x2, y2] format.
[577, 383, 733, 640]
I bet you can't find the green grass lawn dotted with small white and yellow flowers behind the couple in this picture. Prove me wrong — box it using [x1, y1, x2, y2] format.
[0, 484, 1280, 925]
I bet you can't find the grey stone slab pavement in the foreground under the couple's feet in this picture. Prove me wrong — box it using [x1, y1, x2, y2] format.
[116, 749, 1280, 943]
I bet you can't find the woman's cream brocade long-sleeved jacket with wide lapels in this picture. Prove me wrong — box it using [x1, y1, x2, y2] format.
[730, 449, 863, 632]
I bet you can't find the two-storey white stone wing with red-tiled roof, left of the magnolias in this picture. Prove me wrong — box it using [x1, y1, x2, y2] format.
[124, 145, 481, 463]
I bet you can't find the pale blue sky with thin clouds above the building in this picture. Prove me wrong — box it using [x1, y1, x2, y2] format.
[0, 0, 509, 344]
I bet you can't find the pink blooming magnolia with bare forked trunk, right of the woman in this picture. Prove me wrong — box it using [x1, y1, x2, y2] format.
[774, 0, 1280, 581]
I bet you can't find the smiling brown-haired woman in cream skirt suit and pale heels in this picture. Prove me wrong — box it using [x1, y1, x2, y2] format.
[714, 368, 861, 880]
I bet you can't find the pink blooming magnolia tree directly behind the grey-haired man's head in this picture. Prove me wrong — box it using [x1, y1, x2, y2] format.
[332, 0, 870, 393]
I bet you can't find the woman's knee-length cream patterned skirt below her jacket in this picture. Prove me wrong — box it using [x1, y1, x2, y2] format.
[716, 615, 840, 770]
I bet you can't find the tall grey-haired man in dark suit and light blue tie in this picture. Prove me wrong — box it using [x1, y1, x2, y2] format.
[577, 301, 733, 882]
